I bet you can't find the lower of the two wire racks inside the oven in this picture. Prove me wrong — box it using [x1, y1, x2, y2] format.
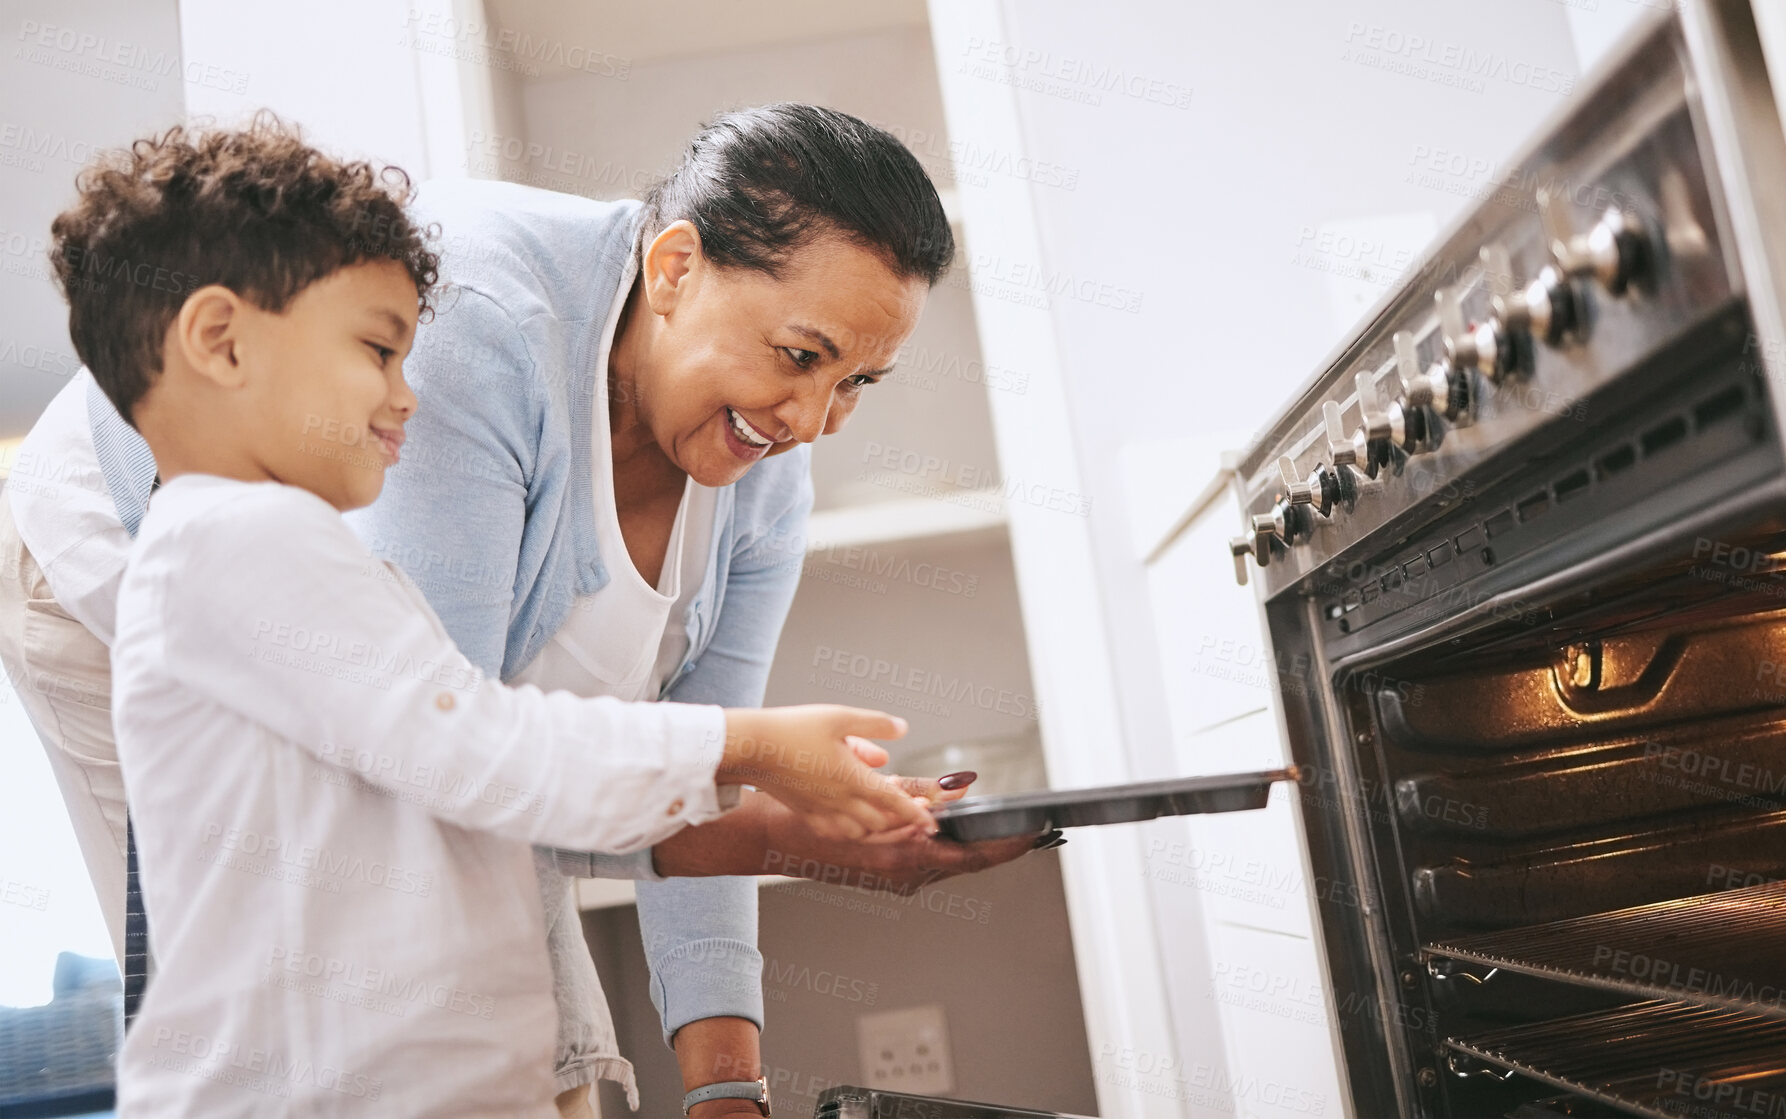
[1445, 1001, 1786, 1119]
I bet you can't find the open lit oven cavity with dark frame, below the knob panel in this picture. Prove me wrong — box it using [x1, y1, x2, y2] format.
[1268, 301, 1786, 1119]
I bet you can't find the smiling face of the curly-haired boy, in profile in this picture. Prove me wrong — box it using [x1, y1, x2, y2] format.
[238, 261, 418, 510]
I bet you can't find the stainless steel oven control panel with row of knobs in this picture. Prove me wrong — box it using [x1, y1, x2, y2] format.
[1229, 84, 1736, 609]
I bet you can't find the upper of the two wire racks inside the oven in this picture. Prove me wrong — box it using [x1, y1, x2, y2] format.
[1420, 882, 1786, 1020]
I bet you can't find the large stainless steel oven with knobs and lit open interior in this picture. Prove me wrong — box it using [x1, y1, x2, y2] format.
[1231, 0, 1786, 1119]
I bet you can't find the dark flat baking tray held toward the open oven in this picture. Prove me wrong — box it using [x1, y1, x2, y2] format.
[932, 766, 1297, 842]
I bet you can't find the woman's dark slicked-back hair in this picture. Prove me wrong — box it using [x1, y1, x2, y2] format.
[641, 102, 956, 284]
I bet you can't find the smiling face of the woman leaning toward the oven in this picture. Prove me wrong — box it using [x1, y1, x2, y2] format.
[611, 221, 929, 485]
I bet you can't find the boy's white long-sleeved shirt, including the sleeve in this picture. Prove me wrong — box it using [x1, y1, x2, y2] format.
[113, 475, 736, 1115]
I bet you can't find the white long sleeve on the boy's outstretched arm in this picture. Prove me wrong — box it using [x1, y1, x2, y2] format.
[150, 484, 725, 851]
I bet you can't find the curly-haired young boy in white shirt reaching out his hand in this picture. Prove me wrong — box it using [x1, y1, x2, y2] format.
[52, 117, 934, 1115]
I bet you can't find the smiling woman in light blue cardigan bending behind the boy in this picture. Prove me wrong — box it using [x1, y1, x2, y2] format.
[0, 104, 1029, 1119]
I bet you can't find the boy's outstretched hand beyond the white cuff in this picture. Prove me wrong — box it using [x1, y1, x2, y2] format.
[716, 703, 936, 839]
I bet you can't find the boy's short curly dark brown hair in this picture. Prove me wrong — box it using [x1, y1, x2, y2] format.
[50, 109, 439, 419]
